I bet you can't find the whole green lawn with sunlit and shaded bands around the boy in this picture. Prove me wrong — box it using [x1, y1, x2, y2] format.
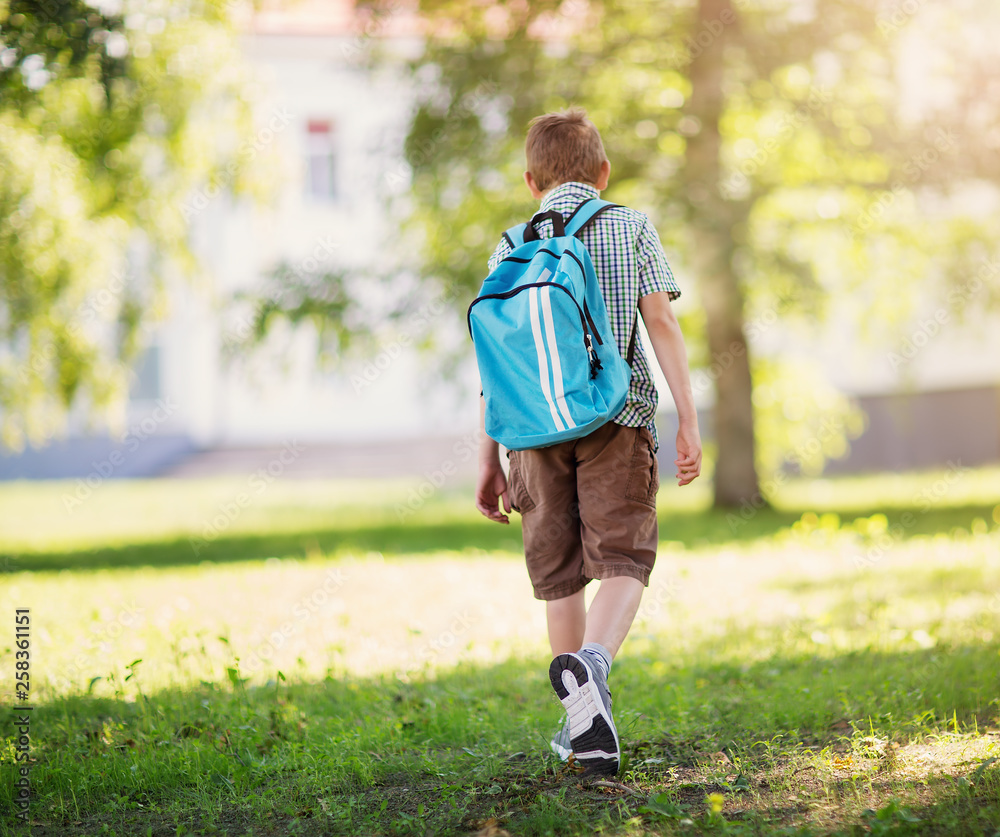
[0, 470, 1000, 837]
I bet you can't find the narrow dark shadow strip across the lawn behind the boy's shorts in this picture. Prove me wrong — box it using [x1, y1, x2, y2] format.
[0, 496, 993, 572]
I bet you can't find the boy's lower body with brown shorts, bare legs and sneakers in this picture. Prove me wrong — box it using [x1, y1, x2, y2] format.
[510, 424, 656, 773]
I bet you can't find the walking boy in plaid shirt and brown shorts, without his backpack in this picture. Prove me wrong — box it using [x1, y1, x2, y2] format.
[476, 108, 701, 774]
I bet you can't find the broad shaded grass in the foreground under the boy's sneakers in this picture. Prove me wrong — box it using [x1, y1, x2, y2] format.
[0, 642, 1000, 837]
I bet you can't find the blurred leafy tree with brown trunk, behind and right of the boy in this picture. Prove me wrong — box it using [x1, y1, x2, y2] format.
[350, 0, 1000, 507]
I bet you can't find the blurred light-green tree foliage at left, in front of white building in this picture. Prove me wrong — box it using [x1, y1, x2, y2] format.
[0, 0, 266, 448]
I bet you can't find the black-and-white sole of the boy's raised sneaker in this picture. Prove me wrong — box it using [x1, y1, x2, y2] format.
[549, 654, 621, 776]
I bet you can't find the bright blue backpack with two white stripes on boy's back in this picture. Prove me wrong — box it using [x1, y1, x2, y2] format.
[468, 198, 635, 450]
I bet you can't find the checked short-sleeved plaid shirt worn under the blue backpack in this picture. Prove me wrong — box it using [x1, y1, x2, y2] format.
[489, 182, 681, 446]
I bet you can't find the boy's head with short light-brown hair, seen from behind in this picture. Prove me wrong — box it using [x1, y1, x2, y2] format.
[524, 108, 610, 198]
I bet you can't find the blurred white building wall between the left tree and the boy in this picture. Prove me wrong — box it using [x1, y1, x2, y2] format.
[148, 27, 476, 446]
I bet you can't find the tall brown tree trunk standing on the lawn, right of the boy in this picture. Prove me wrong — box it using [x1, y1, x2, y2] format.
[684, 0, 762, 508]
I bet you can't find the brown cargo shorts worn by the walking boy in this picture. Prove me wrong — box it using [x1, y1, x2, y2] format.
[508, 422, 660, 600]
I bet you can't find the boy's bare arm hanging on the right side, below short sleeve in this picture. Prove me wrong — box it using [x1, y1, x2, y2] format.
[639, 291, 701, 485]
